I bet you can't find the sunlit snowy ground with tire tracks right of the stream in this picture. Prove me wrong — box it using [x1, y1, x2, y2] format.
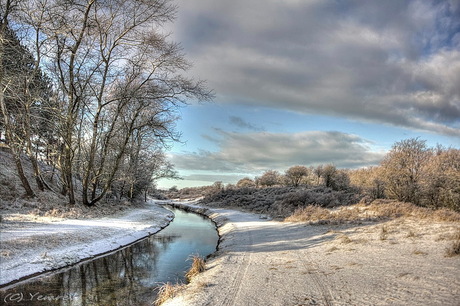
[163, 203, 460, 306]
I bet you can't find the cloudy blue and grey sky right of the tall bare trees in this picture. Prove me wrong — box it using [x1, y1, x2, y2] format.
[158, 0, 460, 188]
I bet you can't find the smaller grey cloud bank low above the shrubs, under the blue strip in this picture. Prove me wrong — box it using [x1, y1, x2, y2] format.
[172, 131, 384, 173]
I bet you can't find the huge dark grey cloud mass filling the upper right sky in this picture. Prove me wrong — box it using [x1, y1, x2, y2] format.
[175, 0, 460, 136]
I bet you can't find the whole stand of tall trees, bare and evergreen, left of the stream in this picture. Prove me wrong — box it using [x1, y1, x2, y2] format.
[0, 0, 212, 206]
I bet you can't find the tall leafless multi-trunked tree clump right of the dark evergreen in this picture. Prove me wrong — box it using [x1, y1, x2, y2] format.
[5, 0, 212, 206]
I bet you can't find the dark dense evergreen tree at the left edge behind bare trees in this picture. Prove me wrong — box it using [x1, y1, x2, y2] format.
[0, 5, 55, 197]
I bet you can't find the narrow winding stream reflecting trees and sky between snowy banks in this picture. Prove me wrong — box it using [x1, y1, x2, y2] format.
[0, 209, 218, 306]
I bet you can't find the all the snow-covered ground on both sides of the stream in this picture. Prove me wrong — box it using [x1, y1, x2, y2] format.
[0, 202, 460, 306]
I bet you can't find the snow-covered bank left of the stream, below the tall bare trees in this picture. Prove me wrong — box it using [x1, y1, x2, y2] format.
[0, 201, 174, 286]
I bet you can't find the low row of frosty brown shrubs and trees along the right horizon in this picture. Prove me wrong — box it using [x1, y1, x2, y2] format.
[171, 138, 460, 212]
